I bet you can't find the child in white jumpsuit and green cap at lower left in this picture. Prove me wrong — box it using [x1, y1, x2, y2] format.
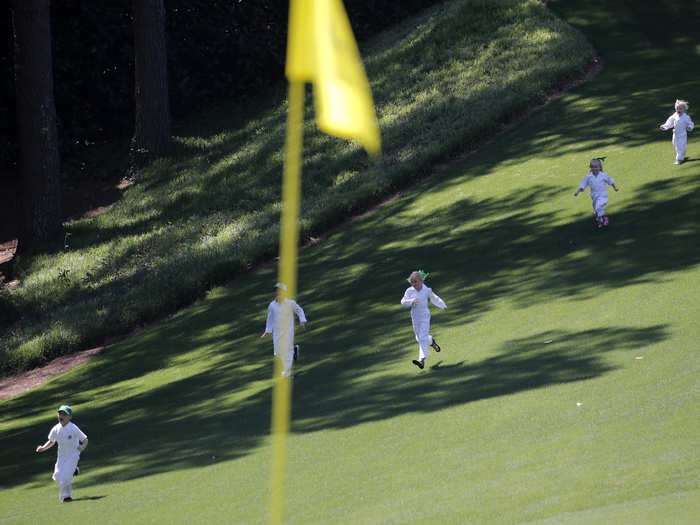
[36, 405, 88, 502]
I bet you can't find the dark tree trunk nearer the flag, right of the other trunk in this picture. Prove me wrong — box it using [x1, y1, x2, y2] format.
[131, 0, 170, 171]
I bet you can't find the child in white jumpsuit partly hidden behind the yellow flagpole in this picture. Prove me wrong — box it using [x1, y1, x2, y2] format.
[260, 283, 306, 377]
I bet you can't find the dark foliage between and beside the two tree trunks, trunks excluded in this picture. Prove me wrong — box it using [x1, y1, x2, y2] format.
[0, 0, 439, 177]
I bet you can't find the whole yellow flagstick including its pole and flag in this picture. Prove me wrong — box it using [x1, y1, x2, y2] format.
[270, 0, 381, 524]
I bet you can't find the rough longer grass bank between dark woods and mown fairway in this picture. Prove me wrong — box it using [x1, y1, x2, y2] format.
[0, 0, 593, 371]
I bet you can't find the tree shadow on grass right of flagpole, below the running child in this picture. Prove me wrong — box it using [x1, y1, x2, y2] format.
[292, 325, 667, 432]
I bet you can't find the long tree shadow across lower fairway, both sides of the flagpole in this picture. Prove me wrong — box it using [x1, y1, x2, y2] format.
[0, 322, 667, 492]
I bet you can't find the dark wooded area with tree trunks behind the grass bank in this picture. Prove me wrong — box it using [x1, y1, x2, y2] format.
[0, 0, 438, 250]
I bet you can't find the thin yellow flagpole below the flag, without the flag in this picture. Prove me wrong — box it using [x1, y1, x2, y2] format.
[270, 81, 304, 525]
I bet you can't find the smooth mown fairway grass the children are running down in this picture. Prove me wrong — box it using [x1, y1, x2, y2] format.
[0, 0, 700, 525]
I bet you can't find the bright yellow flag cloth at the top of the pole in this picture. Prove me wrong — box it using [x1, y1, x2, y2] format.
[286, 0, 381, 155]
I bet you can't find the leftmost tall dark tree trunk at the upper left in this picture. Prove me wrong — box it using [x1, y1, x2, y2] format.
[12, 0, 61, 252]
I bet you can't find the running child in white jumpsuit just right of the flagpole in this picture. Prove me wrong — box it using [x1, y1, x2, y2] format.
[401, 270, 447, 369]
